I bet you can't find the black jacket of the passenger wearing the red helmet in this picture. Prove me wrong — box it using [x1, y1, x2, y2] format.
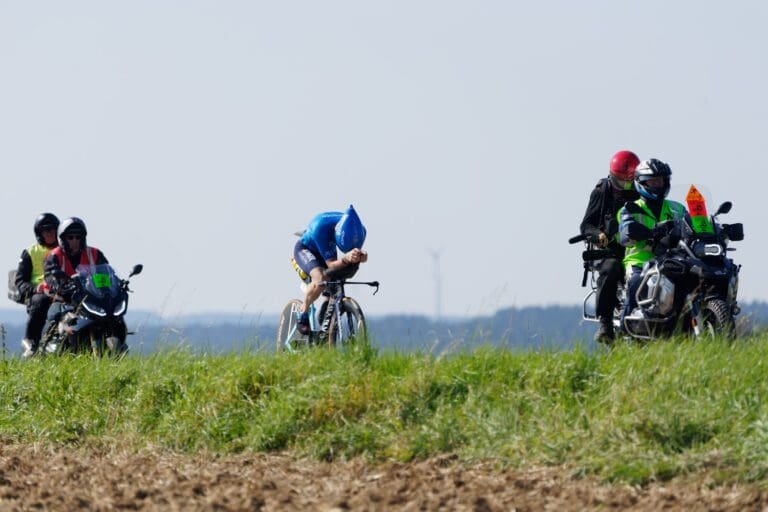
[581, 178, 640, 254]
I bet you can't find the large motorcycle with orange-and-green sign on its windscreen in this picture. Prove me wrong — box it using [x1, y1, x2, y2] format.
[570, 201, 744, 340]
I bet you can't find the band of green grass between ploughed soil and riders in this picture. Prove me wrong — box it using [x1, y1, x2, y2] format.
[0, 336, 768, 485]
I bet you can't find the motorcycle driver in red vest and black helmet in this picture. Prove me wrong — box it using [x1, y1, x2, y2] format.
[44, 217, 109, 331]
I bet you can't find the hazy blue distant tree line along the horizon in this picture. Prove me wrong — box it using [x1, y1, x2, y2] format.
[3, 302, 768, 353]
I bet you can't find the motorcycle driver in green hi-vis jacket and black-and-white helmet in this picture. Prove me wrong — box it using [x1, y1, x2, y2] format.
[618, 158, 690, 324]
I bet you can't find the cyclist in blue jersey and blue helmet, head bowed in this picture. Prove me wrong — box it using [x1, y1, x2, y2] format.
[291, 205, 368, 335]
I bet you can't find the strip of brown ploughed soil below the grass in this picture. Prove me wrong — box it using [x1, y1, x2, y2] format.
[0, 445, 768, 511]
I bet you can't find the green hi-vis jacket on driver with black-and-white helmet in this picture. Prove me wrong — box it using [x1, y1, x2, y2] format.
[616, 197, 688, 269]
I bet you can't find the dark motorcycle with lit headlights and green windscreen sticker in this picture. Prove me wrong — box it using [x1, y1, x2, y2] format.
[41, 264, 144, 357]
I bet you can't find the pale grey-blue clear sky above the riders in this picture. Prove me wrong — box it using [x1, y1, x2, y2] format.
[0, 0, 768, 316]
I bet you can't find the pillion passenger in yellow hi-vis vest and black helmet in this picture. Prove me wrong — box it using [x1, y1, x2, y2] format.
[15, 212, 59, 357]
